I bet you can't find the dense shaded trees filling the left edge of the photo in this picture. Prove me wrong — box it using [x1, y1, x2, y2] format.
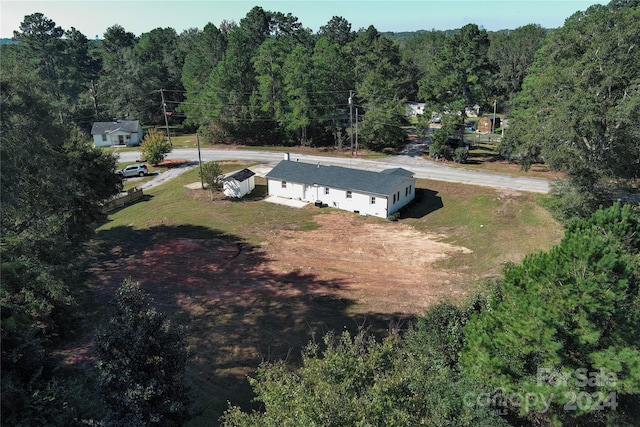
[0, 41, 121, 426]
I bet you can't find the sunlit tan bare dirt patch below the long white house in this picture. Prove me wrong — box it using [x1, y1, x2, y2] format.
[267, 212, 468, 314]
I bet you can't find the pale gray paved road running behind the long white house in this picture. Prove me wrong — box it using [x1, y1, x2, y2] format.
[119, 149, 549, 193]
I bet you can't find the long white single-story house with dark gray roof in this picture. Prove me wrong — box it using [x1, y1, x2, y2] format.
[265, 160, 416, 218]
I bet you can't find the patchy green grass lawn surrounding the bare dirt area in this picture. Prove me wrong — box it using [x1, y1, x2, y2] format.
[87, 162, 562, 427]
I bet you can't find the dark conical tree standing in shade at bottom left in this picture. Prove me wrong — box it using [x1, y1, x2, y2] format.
[94, 280, 193, 426]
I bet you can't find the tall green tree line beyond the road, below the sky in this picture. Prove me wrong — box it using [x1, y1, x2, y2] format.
[3, 7, 545, 150]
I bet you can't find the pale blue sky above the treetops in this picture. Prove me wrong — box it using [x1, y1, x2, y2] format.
[0, 0, 609, 39]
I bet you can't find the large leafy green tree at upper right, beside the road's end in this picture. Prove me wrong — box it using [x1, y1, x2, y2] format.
[501, 5, 640, 218]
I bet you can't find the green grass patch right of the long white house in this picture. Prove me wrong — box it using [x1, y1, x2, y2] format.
[411, 180, 562, 278]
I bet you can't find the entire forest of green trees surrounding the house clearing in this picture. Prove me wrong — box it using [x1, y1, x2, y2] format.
[0, 0, 640, 426]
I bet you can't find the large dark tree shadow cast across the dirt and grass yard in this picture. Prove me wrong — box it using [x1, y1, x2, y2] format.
[87, 226, 408, 426]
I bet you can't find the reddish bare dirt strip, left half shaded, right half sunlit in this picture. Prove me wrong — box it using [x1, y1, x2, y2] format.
[89, 211, 469, 320]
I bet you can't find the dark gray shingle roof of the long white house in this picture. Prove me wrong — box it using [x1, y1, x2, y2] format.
[266, 160, 413, 196]
